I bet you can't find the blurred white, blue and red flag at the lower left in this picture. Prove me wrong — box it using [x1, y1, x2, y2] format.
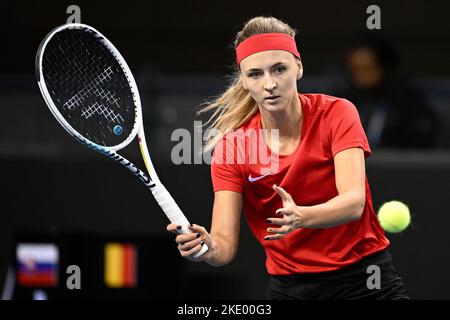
[16, 243, 59, 287]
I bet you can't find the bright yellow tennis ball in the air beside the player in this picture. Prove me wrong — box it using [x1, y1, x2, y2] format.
[378, 201, 411, 233]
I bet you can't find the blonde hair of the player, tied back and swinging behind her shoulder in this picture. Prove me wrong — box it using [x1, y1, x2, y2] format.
[197, 16, 296, 152]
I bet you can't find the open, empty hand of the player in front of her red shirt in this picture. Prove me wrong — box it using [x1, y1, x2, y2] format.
[264, 184, 303, 240]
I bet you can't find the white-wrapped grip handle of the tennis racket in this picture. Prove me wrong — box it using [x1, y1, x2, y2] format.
[150, 184, 208, 258]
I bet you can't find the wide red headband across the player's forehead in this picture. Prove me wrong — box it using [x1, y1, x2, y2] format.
[236, 33, 301, 66]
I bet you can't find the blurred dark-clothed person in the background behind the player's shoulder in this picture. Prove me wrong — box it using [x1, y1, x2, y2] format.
[335, 36, 438, 149]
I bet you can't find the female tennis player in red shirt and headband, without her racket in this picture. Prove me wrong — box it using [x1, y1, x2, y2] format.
[167, 17, 408, 299]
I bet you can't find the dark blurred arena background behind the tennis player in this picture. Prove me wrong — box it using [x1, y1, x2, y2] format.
[0, 0, 450, 299]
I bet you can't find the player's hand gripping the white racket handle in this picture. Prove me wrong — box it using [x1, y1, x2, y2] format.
[167, 223, 212, 262]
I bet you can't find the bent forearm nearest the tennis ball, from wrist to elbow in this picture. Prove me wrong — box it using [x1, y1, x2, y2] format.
[299, 191, 366, 228]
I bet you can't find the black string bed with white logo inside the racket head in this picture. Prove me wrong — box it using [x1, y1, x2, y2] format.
[42, 28, 137, 146]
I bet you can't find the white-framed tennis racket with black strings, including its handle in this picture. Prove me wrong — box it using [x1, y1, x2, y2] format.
[36, 23, 208, 257]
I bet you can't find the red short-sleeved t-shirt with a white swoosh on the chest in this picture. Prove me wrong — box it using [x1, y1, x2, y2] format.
[211, 94, 389, 275]
